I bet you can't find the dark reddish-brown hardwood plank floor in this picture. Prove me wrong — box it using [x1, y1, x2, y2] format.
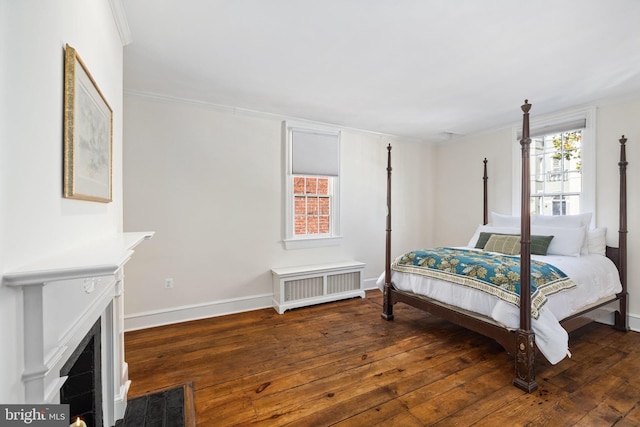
[125, 290, 640, 427]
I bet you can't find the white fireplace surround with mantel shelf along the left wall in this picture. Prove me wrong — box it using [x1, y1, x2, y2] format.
[2, 232, 154, 426]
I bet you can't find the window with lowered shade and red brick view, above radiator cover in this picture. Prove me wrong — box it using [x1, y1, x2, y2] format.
[283, 123, 341, 249]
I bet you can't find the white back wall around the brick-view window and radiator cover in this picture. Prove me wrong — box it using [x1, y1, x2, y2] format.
[124, 95, 434, 328]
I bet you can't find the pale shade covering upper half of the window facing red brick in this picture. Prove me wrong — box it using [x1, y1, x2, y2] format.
[291, 129, 340, 176]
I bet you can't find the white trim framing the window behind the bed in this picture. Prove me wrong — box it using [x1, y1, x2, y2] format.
[511, 107, 596, 226]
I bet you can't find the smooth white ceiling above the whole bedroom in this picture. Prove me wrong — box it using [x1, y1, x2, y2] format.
[124, 0, 640, 141]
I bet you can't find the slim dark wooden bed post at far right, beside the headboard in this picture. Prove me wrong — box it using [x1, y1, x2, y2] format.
[614, 135, 629, 331]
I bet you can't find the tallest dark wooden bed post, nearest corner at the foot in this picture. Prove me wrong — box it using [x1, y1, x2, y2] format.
[513, 100, 538, 393]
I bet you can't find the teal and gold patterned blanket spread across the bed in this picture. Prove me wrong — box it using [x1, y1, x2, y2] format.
[391, 248, 576, 319]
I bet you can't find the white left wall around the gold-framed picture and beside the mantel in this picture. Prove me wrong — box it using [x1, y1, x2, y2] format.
[0, 0, 122, 403]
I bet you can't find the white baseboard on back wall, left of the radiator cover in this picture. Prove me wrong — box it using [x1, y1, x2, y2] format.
[124, 294, 273, 332]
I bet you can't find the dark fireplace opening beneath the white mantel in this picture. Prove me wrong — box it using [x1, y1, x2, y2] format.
[60, 319, 103, 427]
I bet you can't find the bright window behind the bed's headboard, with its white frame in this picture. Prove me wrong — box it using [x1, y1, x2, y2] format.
[512, 108, 596, 221]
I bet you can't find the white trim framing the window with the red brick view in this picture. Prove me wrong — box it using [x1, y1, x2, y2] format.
[282, 121, 342, 249]
